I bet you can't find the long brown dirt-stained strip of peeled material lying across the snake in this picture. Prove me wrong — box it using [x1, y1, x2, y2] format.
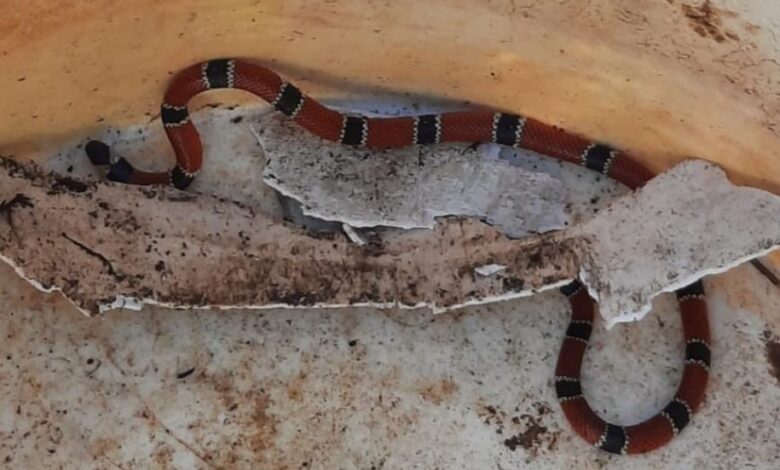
[0, 159, 581, 314]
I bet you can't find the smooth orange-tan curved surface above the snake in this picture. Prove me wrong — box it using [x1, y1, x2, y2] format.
[0, 0, 780, 192]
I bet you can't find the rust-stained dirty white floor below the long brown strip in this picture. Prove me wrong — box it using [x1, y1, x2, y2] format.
[0, 258, 780, 470]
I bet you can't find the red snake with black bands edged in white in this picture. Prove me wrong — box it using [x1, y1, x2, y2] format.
[86, 59, 710, 454]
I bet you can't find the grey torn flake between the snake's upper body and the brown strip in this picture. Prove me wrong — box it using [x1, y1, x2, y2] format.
[256, 115, 569, 238]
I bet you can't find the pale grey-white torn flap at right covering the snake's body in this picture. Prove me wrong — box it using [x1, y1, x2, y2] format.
[569, 160, 780, 327]
